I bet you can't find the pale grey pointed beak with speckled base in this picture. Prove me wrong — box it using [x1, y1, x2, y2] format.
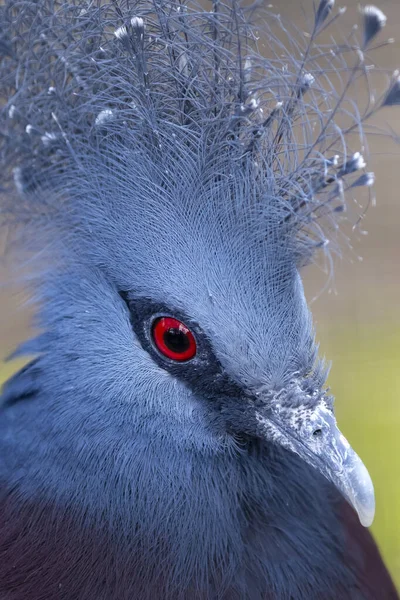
[257, 403, 375, 527]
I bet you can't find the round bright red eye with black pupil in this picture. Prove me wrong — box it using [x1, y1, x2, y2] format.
[152, 317, 196, 362]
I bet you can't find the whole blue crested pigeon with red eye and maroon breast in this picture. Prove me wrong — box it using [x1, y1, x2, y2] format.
[0, 0, 400, 600]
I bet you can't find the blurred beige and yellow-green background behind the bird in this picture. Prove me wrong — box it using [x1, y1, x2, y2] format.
[0, 0, 400, 600]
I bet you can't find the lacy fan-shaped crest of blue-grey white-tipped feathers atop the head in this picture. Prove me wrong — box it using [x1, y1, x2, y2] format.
[0, 0, 400, 263]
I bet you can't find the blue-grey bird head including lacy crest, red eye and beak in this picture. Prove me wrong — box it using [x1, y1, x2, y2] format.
[3, 0, 400, 525]
